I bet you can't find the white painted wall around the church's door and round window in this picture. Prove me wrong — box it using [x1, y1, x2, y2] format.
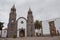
[17, 18, 27, 37]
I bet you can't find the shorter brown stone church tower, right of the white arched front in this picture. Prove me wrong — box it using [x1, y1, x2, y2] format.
[27, 8, 35, 37]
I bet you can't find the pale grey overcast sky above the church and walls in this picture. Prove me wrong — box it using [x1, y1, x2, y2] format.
[0, 0, 60, 27]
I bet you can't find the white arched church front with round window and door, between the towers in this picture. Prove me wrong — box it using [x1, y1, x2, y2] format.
[17, 17, 27, 37]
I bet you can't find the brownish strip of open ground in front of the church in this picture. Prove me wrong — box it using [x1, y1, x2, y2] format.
[0, 36, 60, 40]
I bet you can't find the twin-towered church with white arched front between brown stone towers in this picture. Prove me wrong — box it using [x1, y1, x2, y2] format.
[7, 5, 35, 37]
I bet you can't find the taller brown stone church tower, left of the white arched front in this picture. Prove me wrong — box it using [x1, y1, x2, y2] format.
[7, 5, 17, 37]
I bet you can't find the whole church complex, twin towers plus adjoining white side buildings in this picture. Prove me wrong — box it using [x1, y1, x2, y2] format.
[0, 5, 60, 38]
